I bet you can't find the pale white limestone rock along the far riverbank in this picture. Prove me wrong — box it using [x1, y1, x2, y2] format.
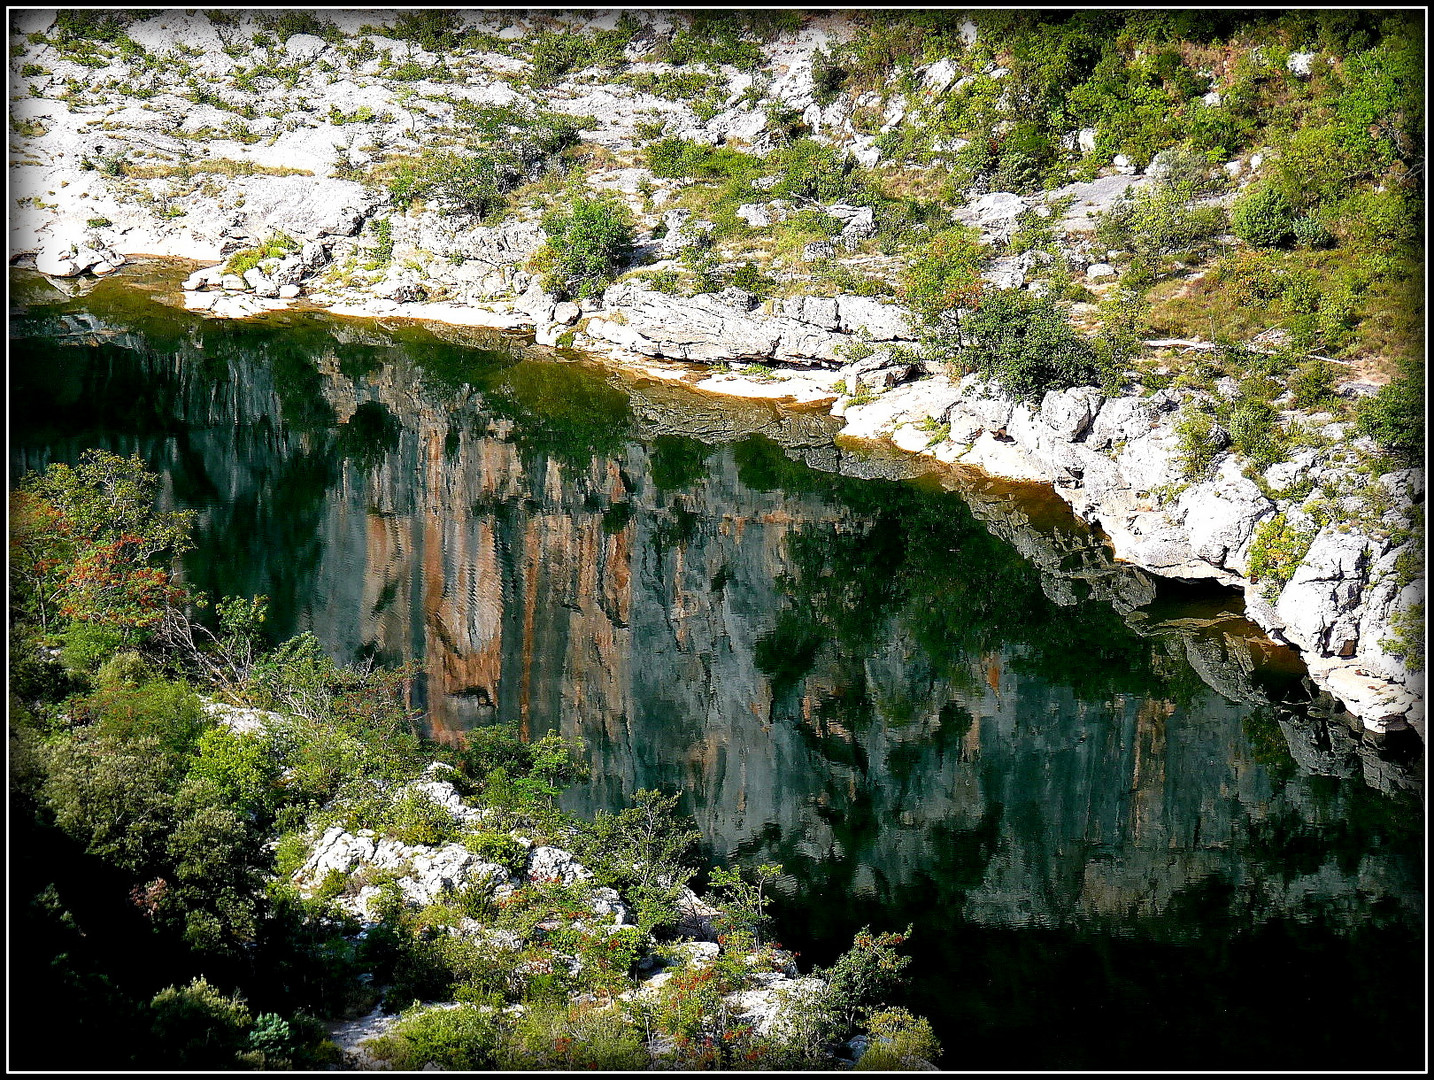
[10, 11, 1424, 733]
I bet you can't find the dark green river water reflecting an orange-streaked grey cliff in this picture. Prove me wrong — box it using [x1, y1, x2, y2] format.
[10, 267, 1424, 1070]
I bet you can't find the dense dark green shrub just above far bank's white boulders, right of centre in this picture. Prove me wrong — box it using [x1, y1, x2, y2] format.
[958, 290, 1106, 399]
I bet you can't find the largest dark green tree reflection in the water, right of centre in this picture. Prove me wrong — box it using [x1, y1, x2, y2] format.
[737, 436, 1206, 751]
